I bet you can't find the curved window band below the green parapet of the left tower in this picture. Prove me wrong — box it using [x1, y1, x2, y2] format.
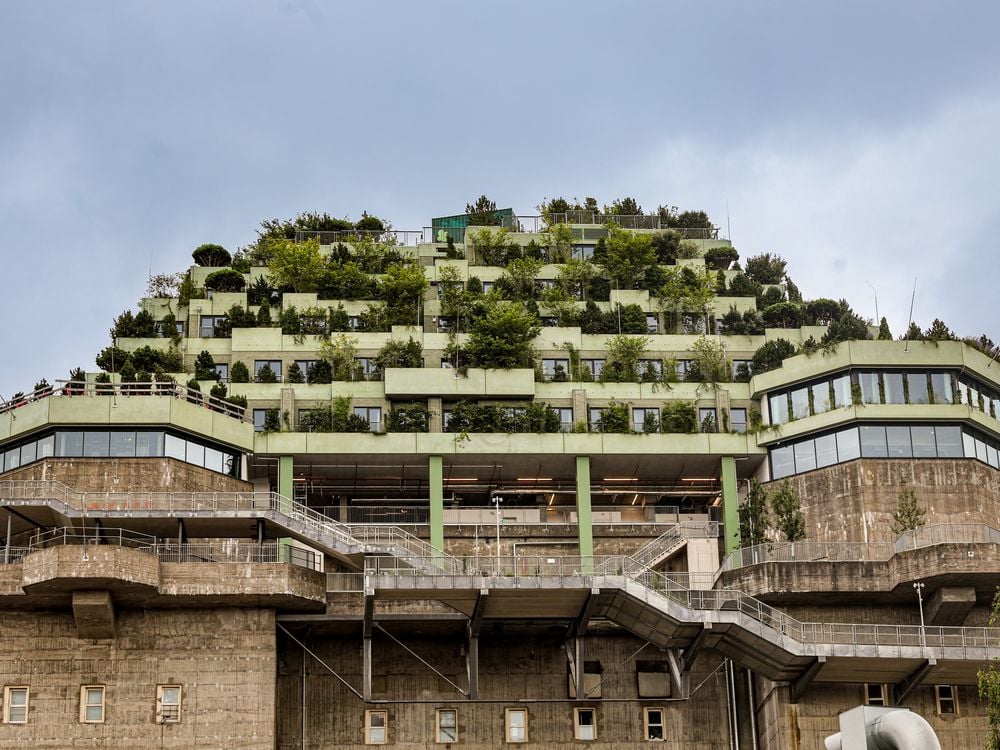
[0, 429, 240, 477]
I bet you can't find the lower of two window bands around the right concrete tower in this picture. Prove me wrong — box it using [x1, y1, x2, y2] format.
[770, 424, 988, 479]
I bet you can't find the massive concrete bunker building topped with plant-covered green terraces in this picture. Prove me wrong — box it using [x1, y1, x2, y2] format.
[0, 211, 1000, 750]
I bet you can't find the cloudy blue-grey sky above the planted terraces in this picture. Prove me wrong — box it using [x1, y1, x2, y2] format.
[0, 0, 1000, 397]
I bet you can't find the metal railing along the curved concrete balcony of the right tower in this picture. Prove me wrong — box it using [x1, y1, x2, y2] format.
[719, 523, 1000, 573]
